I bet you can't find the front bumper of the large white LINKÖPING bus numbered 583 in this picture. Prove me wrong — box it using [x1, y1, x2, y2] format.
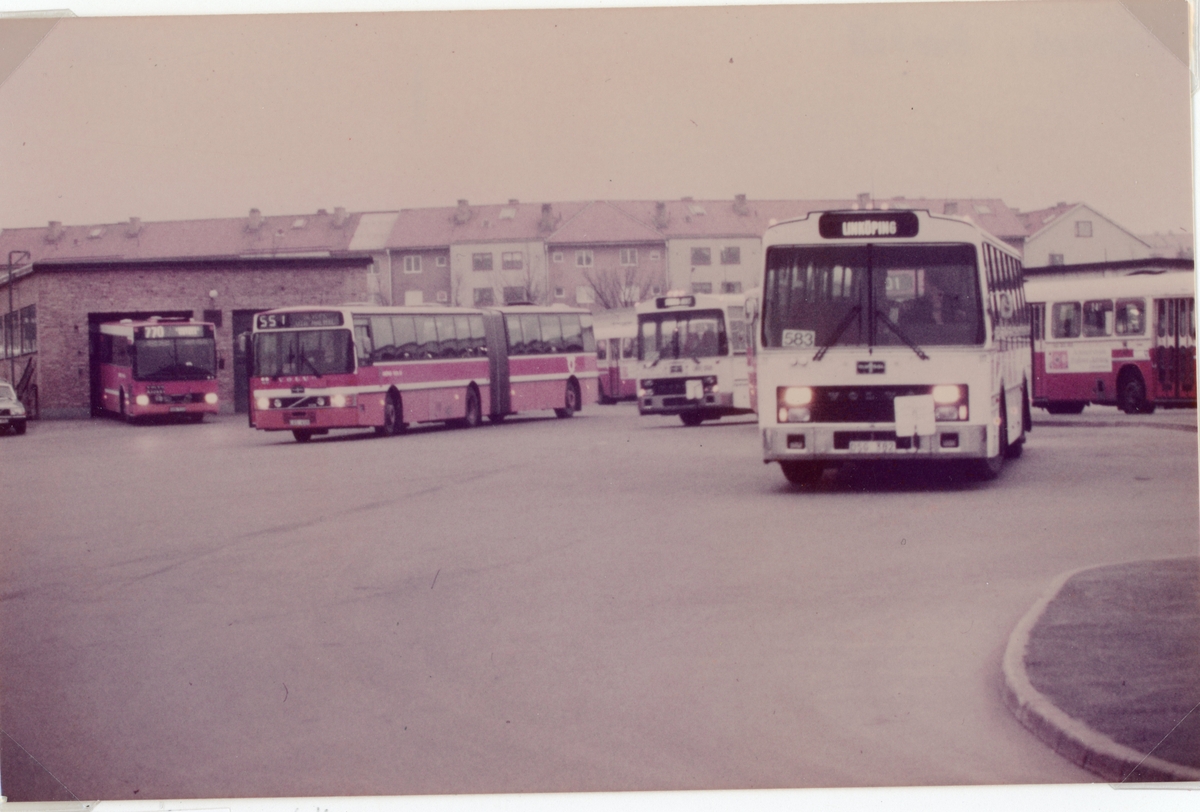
[762, 423, 988, 462]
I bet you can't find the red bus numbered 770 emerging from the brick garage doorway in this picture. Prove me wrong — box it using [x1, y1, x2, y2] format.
[98, 318, 218, 422]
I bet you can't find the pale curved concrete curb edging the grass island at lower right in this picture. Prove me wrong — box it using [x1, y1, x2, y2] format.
[1002, 565, 1200, 783]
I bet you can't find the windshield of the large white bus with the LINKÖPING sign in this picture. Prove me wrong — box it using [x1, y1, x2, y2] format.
[762, 243, 984, 349]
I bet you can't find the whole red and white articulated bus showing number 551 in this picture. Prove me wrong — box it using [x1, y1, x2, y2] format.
[250, 305, 598, 443]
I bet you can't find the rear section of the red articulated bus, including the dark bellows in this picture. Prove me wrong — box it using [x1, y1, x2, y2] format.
[484, 305, 600, 421]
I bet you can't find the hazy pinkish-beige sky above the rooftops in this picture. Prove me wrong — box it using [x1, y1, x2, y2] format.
[0, 0, 1193, 234]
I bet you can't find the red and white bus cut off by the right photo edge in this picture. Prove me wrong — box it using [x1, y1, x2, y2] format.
[1025, 272, 1196, 414]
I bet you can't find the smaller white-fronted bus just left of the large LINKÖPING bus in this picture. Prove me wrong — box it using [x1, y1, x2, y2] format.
[635, 293, 752, 426]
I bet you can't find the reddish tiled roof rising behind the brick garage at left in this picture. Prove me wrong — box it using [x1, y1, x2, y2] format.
[0, 210, 360, 263]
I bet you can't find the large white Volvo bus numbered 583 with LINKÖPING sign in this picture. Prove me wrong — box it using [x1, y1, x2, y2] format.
[755, 210, 1031, 485]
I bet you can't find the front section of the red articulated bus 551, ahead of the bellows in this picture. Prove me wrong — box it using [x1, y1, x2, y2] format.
[250, 306, 492, 443]
